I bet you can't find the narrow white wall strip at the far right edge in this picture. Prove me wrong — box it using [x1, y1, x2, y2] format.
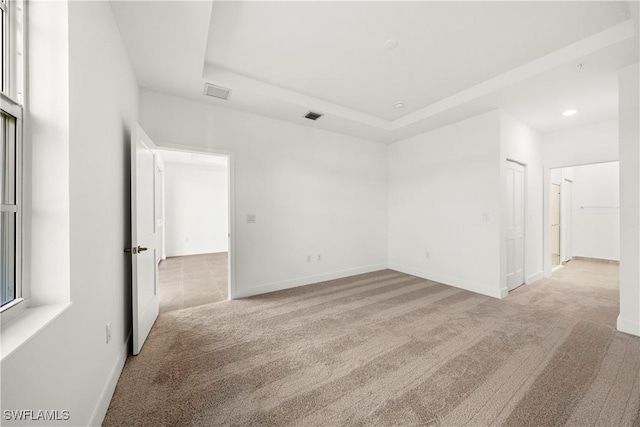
[618, 62, 640, 335]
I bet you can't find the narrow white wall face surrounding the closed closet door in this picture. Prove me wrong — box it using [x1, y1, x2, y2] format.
[500, 112, 544, 288]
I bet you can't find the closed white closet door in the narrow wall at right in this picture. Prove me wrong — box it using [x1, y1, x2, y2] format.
[507, 162, 524, 290]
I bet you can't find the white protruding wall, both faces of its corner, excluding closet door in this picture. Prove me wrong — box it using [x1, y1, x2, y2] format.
[389, 111, 543, 297]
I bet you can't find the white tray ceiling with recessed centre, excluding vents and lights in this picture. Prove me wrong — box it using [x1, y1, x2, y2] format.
[112, 1, 639, 143]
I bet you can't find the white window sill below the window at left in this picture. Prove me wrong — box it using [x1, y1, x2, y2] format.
[0, 302, 71, 361]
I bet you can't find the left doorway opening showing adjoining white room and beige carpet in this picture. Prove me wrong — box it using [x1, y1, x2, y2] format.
[156, 150, 231, 313]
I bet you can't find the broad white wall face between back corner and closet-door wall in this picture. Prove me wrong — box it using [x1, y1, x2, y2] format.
[388, 111, 501, 297]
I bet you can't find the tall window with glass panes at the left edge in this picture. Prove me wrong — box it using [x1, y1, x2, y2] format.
[0, 0, 23, 310]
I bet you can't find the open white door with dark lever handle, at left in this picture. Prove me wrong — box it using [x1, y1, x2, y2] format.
[130, 125, 159, 354]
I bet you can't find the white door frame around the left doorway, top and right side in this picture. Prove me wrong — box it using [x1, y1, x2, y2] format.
[156, 142, 236, 300]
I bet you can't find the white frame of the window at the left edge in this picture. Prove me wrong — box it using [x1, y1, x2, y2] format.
[0, 0, 27, 322]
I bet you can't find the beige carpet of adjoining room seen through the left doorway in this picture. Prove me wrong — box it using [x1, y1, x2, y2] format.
[158, 252, 228, 313]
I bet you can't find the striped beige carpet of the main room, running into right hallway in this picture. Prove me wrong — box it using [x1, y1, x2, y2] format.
[104, 261, 640, 426]
